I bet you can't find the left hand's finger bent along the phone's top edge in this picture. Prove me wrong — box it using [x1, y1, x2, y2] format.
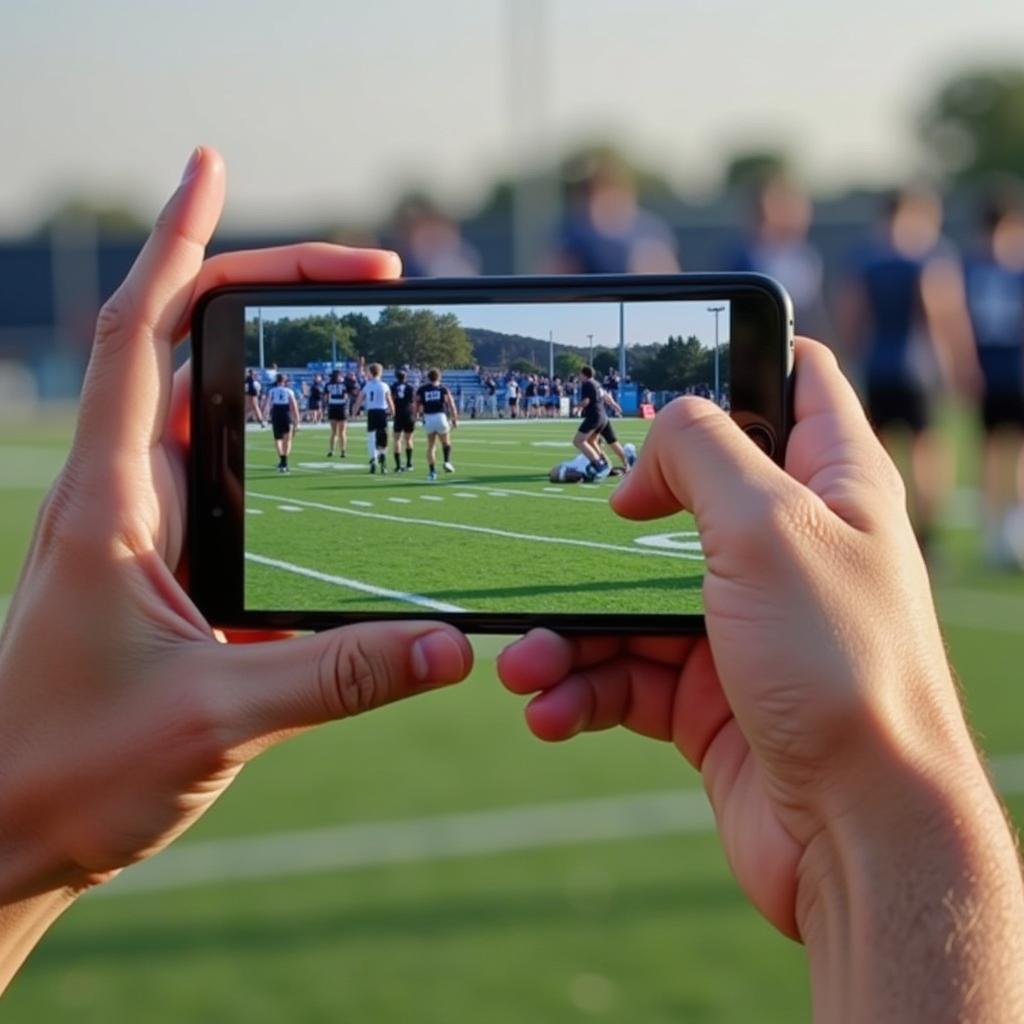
[177, 242, 401, 337]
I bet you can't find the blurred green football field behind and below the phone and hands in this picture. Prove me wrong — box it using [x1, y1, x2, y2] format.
[0, 403, 1024, 1024]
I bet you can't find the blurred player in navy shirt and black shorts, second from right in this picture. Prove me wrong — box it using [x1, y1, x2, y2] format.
[842, 186, 977, 549]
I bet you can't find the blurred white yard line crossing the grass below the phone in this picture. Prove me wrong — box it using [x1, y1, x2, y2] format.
[94, 754, 1024, 899]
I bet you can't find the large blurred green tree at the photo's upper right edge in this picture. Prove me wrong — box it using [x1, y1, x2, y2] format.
[920, 67, 1024, 180]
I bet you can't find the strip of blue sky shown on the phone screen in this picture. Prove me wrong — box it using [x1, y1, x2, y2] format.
[246, 301, 729, 347]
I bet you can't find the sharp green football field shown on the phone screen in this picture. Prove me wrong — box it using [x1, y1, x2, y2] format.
[245, 419, 703, 613]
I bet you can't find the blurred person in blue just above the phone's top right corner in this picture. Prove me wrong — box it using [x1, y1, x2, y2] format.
[725, 174, 833, 338]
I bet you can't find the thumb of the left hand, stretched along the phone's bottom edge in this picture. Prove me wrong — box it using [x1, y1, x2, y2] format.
[205, 622, 473, 749]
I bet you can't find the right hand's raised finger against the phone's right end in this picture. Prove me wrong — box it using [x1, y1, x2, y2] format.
[785, 338, 905, 528]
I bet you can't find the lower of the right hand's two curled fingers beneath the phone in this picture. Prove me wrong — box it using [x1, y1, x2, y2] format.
[526, 656, 679, 741]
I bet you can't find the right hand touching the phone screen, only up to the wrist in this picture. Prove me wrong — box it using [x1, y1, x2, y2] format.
[499, 340, 1011, 936]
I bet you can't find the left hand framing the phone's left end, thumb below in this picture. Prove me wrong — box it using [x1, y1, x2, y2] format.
[0, 150, 472, 904]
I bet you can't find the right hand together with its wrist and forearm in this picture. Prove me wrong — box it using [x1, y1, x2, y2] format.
[499, 340, 1024, 1024]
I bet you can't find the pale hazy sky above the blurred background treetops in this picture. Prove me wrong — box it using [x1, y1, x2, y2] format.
[0, 0, 1024, 236]
